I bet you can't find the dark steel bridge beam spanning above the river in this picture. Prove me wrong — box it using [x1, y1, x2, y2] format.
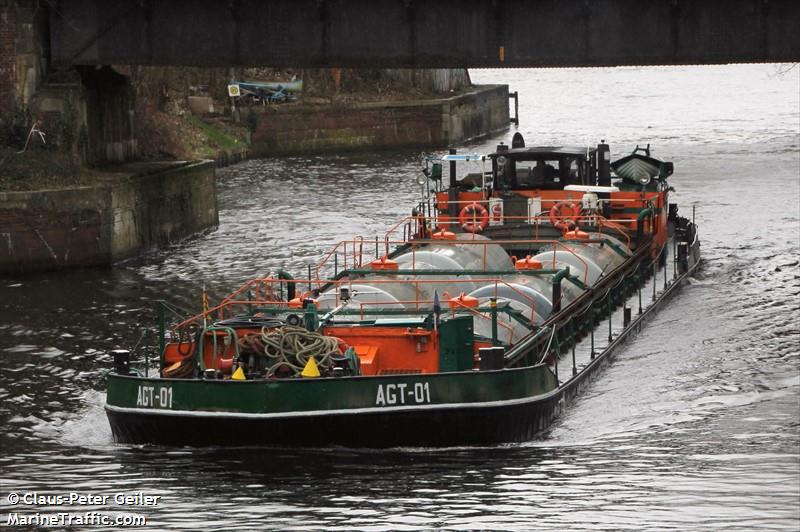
[49, 0, 800, 68]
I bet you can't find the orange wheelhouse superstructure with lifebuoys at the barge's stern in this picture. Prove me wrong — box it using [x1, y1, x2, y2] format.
[424, 133, 672, 262]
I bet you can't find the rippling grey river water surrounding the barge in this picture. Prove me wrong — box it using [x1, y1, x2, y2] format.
[0, 65, 800, 531]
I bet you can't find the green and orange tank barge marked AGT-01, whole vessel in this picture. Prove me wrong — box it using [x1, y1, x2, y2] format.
[105, 134, 700, 448]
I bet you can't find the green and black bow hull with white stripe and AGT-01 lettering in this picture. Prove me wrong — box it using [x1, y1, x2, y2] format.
[106, 365, 559, 447]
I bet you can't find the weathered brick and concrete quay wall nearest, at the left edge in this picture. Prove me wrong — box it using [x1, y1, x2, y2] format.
[0, 161, 219, 272]
